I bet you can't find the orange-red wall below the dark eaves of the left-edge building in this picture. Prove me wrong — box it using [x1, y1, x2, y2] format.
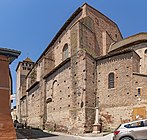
[0, 55, 16, 140]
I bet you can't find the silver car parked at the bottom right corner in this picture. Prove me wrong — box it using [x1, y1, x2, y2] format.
[113, 119, 147, 140]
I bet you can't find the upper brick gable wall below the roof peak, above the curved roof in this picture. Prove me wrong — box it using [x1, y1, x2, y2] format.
[87, 6, 122, 55]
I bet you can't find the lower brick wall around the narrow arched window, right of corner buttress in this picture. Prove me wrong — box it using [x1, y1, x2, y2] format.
[97, 52, 142, 127]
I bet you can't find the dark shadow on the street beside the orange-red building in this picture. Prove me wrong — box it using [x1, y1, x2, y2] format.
[16, 128, 58, 139]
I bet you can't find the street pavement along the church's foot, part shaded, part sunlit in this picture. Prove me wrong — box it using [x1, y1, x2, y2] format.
[17, 129, 113, 140]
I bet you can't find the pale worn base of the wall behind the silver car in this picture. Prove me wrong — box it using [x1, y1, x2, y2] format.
[100, 104, 147, 131]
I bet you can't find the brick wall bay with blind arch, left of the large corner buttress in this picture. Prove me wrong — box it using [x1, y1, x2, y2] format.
[45, 62, 72, 131]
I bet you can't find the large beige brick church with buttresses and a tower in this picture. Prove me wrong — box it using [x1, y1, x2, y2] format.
[16, 4, 147, 133]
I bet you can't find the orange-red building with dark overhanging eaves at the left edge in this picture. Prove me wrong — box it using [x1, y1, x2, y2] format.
[0, 48, 20, 140]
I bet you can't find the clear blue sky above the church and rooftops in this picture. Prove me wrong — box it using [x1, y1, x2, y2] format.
[0, 0, 147, 105]
